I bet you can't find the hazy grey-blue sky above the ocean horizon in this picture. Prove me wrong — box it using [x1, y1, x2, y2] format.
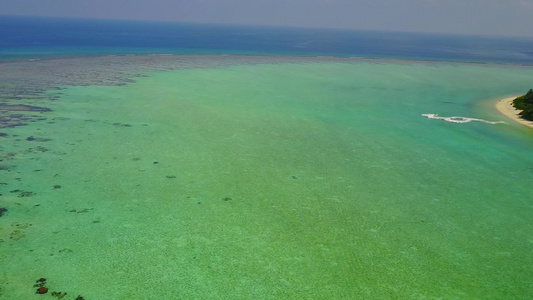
[0, 0, 533, 37]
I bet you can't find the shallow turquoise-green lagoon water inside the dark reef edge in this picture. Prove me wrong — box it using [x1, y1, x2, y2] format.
[0, 60, 533, 299]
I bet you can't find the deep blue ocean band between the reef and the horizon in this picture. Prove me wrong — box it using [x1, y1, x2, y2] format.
[0, 16, 533, 65]
